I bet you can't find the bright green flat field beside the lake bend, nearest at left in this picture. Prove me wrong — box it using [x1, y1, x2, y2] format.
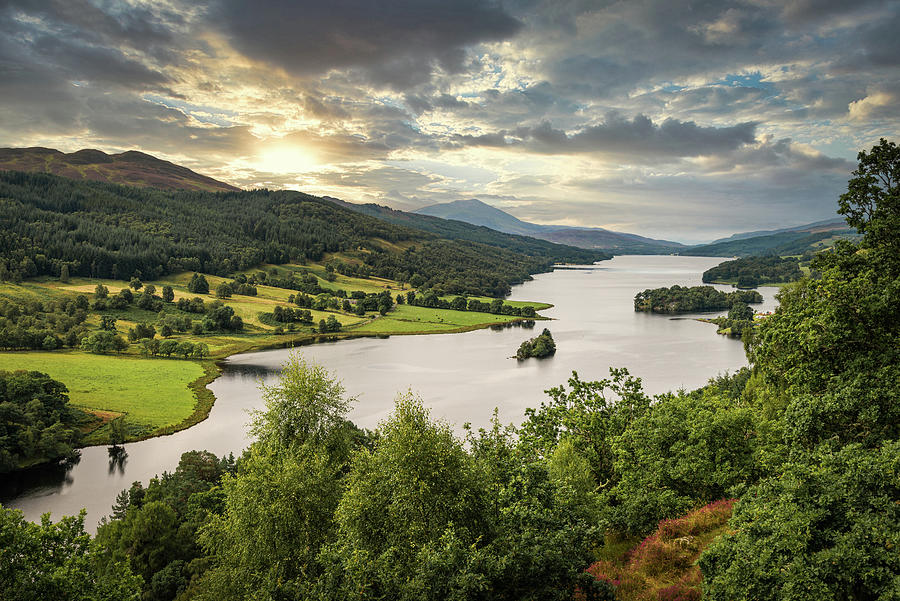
[0, 351, 205, 435]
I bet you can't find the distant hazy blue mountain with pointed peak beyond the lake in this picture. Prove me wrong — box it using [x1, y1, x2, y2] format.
[415, 198, 684, 254]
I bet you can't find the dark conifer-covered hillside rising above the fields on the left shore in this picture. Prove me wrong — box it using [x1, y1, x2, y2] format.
[0, 172, 608, 296]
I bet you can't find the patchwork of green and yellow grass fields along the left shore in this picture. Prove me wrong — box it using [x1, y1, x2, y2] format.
[0, 265, 552, 444]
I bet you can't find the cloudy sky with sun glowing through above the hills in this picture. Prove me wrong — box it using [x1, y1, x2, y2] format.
[0, 0, 900, 242]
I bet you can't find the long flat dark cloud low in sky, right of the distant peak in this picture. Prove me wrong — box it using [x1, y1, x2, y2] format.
[453, 114, 757, 160]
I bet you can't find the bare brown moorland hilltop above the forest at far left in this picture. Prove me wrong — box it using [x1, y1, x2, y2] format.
[0, 147, 240, 192]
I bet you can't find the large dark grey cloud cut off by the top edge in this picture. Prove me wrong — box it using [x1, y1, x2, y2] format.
[213, 0, 519, 89]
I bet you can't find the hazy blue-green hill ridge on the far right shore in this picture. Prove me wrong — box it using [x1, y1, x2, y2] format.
[678, 219, 856, 257]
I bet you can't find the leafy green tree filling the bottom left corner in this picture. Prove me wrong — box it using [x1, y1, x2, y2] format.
[0, 507, 141, 601]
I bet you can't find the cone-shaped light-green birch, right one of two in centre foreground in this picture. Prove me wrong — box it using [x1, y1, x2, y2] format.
[324, 395, 489, 598]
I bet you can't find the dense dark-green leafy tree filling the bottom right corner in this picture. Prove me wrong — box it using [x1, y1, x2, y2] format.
[700, 441, 900, 601]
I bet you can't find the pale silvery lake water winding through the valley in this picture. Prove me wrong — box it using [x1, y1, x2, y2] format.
[0, 256, 776, 530]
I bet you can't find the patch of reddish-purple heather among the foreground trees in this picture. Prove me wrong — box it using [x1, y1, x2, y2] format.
[588, 499, 737, 601]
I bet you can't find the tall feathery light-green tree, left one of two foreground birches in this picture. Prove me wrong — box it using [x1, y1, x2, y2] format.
[200, 353, 352, 601]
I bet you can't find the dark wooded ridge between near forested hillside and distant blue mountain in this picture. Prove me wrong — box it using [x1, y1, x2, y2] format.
[323, 196, 612, 264]
